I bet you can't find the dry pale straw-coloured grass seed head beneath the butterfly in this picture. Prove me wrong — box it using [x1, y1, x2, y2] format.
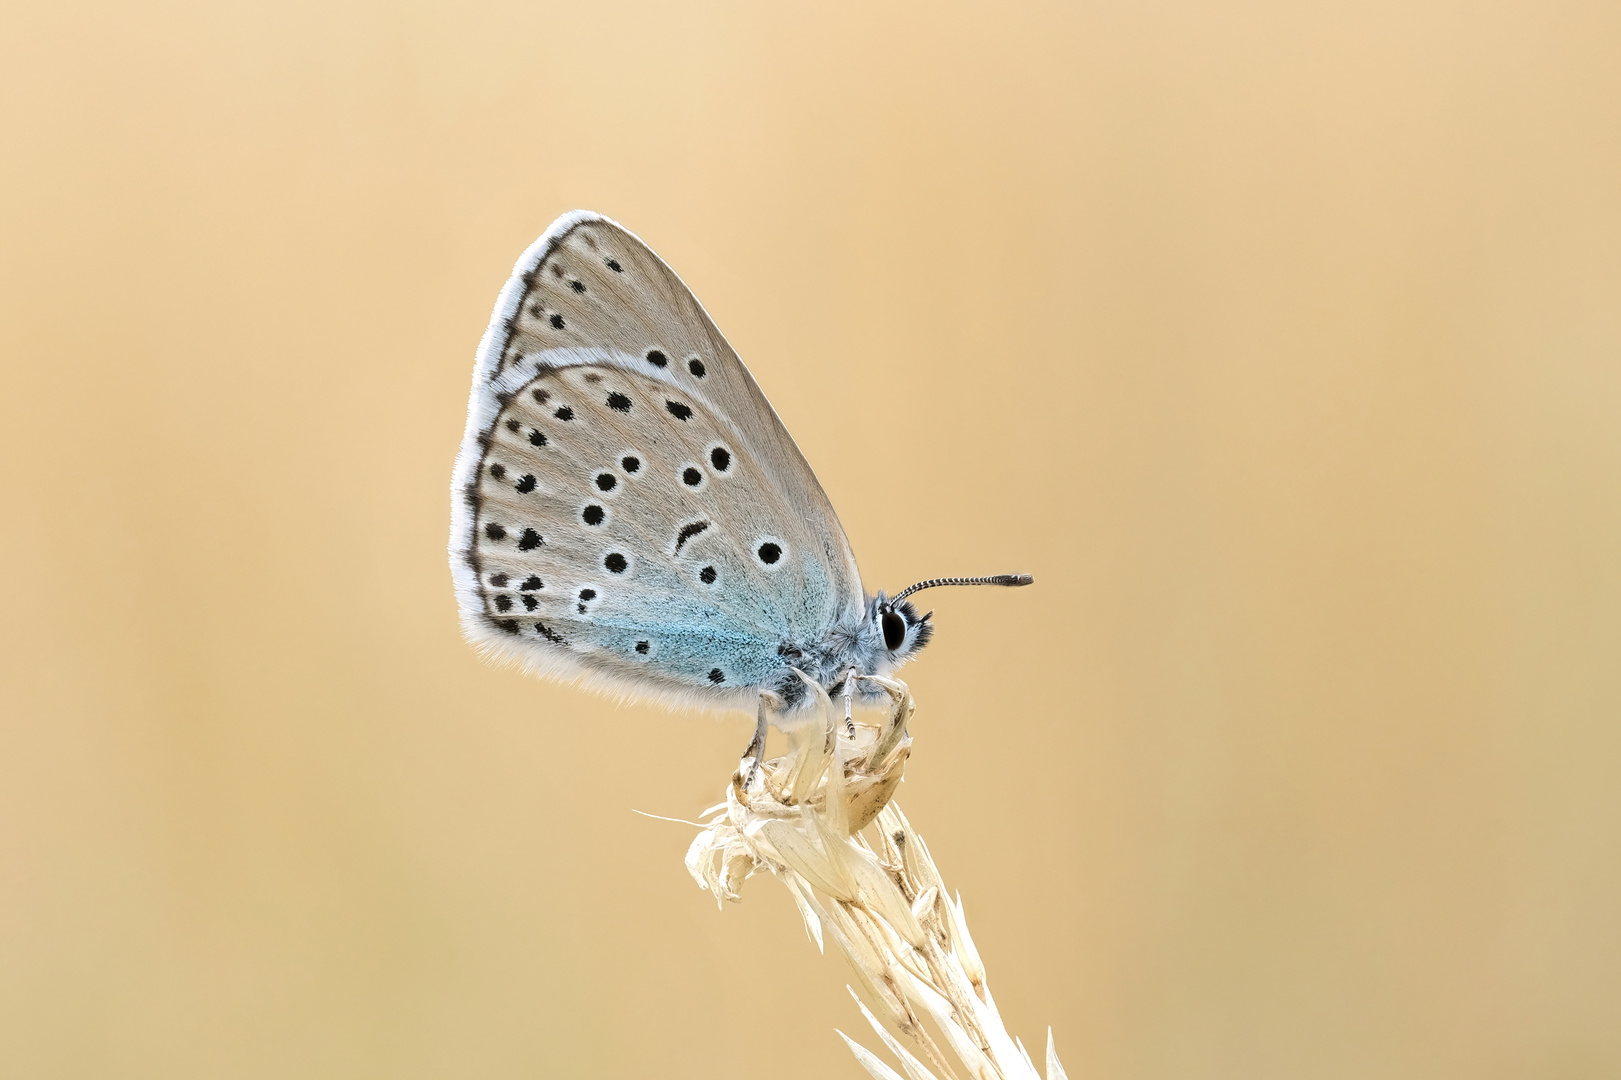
[687, 678, 1065, 1080]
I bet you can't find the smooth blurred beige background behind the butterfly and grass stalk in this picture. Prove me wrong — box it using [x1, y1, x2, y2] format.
[0, 0, 1621, 1080]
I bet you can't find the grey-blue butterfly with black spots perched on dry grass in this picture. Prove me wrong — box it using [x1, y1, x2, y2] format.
[451, 211, 1031, 757]
